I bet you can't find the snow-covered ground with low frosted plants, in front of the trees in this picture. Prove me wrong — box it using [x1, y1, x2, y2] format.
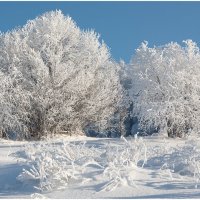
[0, 136, 200, 199]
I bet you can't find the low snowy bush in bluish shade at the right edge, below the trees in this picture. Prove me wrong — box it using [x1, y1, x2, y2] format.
[145, 139, 200, 188]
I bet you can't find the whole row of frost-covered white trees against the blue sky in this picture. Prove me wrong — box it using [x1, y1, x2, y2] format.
[0, 10, 200, 139]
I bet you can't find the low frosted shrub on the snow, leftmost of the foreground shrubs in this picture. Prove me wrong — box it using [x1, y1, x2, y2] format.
[17, 142, 101, 192]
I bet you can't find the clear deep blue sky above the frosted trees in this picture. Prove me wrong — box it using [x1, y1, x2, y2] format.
[0, 2, 200, 62]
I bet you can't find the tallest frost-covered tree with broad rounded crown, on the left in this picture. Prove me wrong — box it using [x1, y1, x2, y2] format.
[0, 11, 124, 137]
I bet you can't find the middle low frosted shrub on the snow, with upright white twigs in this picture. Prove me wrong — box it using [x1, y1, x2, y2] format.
[102, 137, 147, 191]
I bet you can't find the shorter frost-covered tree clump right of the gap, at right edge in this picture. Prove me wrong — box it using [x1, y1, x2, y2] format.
[128, 40, 200, 137]
